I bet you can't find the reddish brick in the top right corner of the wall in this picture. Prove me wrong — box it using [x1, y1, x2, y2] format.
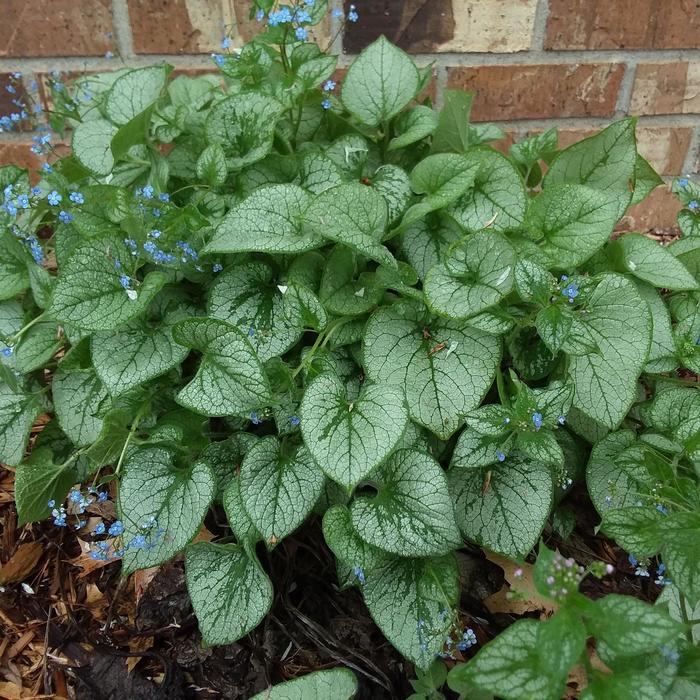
[545, 0, 700, 50]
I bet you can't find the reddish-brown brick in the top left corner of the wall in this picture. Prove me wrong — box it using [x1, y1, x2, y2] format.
[0, 0, 115, 57]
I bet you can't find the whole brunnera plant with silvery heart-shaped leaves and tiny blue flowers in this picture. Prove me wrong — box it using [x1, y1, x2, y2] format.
[0, 0, 700, 698]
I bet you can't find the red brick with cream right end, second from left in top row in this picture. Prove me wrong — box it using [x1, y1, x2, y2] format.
[127, 0, 224, 54]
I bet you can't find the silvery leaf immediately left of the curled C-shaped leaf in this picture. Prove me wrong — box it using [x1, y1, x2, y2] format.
[91, 323, 188, 396]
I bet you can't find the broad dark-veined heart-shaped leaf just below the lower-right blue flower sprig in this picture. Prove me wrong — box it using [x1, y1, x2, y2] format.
[447, 455, 553, 559]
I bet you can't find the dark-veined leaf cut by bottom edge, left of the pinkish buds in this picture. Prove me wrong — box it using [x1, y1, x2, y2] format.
[450, 620, 561, 700]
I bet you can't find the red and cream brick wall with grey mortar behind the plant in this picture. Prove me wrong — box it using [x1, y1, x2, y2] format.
[0, 0, 700, 229]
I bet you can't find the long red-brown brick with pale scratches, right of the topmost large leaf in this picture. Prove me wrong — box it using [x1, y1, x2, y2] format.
[448, 63, 625, 121]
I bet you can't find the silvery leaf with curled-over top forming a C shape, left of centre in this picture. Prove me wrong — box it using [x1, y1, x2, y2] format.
[173, 318, 270, 416]
